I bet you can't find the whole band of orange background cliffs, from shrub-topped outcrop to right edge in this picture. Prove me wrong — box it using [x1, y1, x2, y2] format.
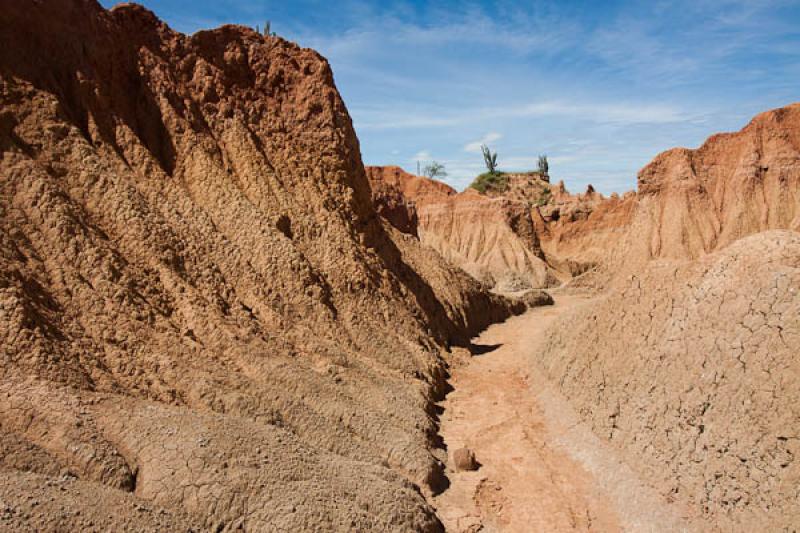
[370, 104, 800, 289]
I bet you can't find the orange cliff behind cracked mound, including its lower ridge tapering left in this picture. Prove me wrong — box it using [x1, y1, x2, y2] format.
[541, 104, 800, 279]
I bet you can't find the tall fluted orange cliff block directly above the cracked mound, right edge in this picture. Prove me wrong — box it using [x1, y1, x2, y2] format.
[633, 104, 800, 258]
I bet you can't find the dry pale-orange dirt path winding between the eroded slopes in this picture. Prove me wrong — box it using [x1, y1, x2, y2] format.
[434, 295, 695, 533]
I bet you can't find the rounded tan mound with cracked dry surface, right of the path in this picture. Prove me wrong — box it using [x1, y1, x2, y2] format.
[538, 231, 800, 531]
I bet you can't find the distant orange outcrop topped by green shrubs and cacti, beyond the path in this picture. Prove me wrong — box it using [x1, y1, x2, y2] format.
[367, 167, 620, 293]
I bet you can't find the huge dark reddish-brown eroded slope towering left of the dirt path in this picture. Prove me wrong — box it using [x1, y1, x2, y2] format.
[0, 0, 521, 531]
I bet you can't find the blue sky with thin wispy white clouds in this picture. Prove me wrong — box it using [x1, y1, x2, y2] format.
[101, 0, 800, 193]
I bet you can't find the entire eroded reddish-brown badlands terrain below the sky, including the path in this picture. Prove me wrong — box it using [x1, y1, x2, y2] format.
[0, 0, 800, 532]
